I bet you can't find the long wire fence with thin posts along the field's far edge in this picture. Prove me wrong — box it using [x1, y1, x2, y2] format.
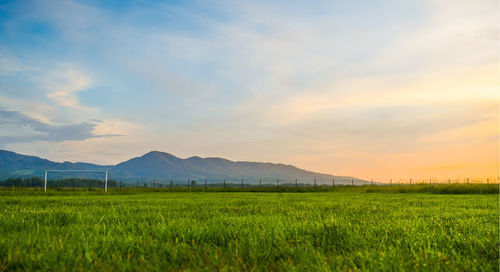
[0, 177, 499, 191]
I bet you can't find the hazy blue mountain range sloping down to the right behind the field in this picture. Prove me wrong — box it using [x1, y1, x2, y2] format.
[0, 150, 366, 184]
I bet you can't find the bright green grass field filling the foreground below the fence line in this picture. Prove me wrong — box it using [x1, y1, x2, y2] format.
[0, 191, 499, 271]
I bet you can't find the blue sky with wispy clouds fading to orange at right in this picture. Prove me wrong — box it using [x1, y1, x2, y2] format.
[0, 0, 500, 181]
